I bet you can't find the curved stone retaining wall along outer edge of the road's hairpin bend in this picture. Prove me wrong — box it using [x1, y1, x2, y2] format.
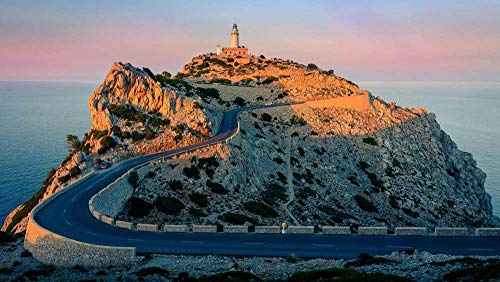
[24, 173, 136, 267]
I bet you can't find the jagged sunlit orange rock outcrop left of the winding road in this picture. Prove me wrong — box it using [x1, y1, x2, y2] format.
[2, 62, 222, 233]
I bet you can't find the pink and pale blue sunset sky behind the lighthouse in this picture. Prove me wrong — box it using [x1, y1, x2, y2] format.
[0, 0, 500, 81]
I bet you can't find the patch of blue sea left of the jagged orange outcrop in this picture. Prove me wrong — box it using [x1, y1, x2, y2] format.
[0, 81, 94, 223]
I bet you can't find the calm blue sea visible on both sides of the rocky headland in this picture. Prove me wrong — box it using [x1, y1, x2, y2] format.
[0, 81, 500, 222]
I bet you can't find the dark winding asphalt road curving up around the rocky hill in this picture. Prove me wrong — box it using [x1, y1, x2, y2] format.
[34, 107, 500, 258]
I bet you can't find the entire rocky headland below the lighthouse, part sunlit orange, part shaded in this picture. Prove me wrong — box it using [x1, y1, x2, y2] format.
[3, 54, 499, 232]
